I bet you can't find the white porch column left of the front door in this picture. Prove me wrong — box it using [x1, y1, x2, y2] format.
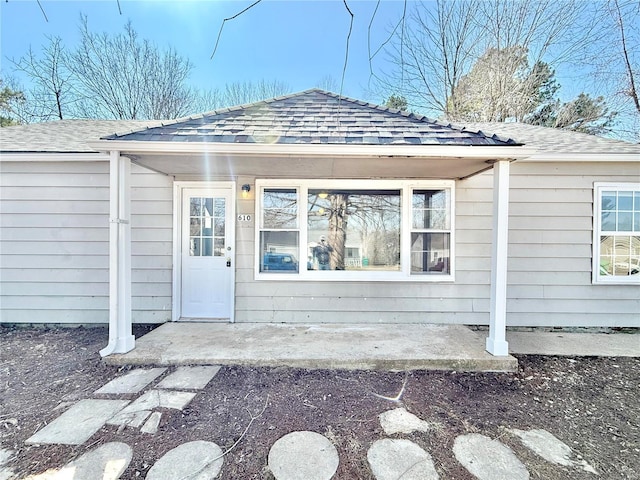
[100, 151, 135, 357]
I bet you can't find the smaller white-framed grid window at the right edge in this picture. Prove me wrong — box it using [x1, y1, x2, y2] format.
[593, 183, 640, 284]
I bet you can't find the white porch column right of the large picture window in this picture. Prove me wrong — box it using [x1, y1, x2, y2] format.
[486, 160, 509, 355]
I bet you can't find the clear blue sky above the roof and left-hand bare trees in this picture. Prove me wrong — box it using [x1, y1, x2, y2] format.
[0, 0, 404, 102]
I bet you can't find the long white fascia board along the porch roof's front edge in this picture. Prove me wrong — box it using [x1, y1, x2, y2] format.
[89, 140, 535, 160]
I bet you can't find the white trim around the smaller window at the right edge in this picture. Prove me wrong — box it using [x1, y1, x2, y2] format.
[591, 182, 640, 285]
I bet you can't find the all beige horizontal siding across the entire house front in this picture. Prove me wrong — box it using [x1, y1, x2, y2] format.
[0, 157, 640, 327]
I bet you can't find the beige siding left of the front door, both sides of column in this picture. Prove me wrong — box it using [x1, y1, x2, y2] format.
[0, 161, 172, 324]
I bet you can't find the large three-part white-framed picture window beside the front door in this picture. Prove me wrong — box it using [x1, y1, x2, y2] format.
[256, 180, 454, 281]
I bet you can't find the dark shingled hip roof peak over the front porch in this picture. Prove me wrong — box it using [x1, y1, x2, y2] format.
[103, 89, 521, 146]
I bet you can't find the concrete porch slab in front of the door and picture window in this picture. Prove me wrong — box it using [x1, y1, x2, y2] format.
[105, 322, 518, 371]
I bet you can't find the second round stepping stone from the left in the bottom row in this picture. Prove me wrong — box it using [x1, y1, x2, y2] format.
[146, 440, 224, 480]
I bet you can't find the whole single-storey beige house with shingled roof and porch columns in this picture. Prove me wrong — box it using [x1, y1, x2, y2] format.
[0, 90, 640, 355]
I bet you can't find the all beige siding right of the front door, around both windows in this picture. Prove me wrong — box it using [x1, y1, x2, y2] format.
[236, 163, 640, 327]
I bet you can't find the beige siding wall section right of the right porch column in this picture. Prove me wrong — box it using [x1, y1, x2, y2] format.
[507, 162, 640, 327]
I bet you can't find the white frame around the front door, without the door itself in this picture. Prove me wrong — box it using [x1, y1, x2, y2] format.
[171, 181, 237, 323]
